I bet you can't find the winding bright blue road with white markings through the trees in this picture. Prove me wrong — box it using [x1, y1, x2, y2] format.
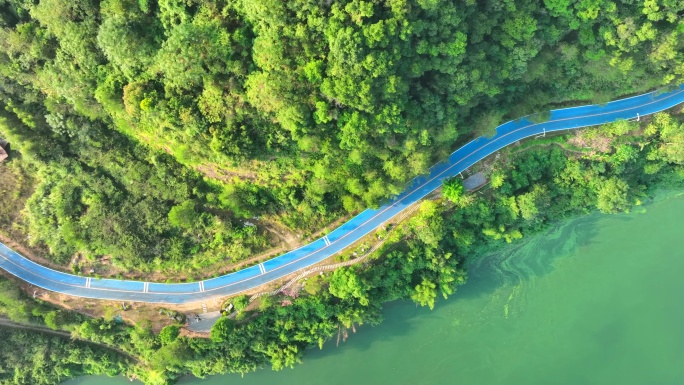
[0, 85, 684, 304]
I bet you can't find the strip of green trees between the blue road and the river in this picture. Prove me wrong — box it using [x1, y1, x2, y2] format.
[0, 108, 684, 384]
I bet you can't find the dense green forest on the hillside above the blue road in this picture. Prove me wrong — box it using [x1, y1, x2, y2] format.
[0, 0, 684, 272]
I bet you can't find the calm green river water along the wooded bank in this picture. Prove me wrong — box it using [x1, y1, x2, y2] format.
[62, 194, 684, 385]
